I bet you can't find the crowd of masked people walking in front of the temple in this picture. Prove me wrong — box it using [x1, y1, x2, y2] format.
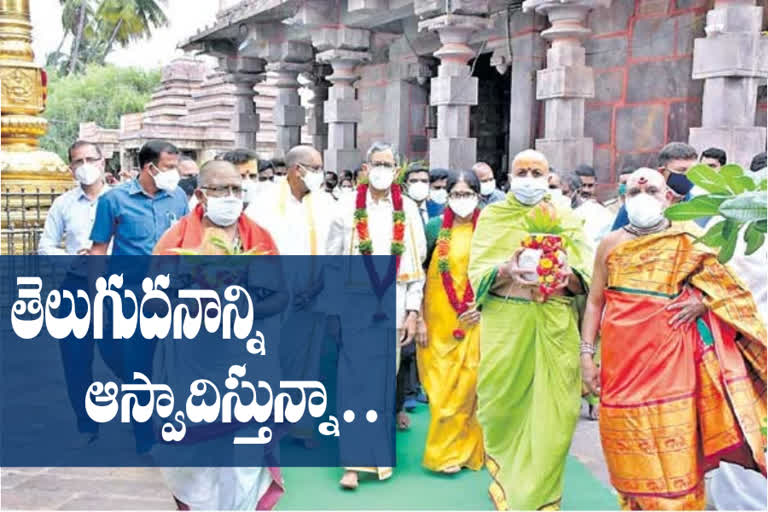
[40, 137, 768, 510]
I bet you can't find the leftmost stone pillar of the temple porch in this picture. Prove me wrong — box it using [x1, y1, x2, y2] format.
[220, 57, 264, 150]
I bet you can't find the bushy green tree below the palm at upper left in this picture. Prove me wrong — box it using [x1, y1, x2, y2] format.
[41, 66, 161, 161]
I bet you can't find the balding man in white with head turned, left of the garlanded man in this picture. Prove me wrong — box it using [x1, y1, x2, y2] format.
[245, 145, 336, 447]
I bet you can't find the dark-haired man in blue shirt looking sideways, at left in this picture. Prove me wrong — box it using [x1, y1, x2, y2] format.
[90, 140, 188, 256]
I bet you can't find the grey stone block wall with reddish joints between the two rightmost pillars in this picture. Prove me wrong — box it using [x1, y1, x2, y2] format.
[584, 0, 711, 183]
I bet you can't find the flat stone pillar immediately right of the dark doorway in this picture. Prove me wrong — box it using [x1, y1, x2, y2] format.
[489, 12, 547, 159]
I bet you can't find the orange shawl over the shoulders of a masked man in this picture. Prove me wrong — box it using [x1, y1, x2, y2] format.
[152, 204, 278, 255]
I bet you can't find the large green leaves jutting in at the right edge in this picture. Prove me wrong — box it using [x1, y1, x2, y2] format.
[665, 164, 768, 263]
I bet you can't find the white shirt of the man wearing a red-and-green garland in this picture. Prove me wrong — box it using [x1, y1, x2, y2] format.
[327, 191, 427, 328]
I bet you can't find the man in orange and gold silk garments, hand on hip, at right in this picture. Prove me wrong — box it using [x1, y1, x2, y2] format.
[580, 168, 766, 510]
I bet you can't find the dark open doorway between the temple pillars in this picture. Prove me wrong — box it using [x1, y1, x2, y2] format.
[469, 53, 510, 180]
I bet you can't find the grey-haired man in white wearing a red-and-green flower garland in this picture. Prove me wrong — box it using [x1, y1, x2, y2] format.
[327, 143, 426, 489]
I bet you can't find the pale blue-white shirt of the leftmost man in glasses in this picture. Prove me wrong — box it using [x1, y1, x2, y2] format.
[38, 183, 110, 256]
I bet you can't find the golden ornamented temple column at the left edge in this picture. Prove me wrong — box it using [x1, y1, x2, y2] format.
[0, 0, 73, 254]
